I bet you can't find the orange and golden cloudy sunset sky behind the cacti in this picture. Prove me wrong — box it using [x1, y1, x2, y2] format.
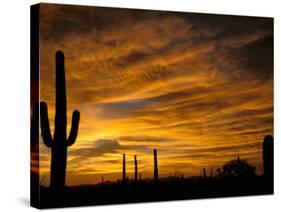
[36, 4, 273, 185]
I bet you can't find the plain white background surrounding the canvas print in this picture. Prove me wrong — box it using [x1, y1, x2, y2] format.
[0, 0, 281, 212]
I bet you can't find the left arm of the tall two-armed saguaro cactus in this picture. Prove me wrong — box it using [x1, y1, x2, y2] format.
[40, 102, 53, 147]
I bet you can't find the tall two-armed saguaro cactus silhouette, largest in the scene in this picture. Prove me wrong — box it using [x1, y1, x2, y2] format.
[40, 51, 80, 190]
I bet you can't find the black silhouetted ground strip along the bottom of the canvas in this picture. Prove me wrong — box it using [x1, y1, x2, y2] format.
[40, 175, 273, 208]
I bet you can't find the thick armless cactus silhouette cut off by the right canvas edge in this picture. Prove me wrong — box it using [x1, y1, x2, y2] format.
[263, 135, 273, 181]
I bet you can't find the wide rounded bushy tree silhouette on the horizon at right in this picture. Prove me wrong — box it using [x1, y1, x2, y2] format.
[217, 157, 256, 177]
